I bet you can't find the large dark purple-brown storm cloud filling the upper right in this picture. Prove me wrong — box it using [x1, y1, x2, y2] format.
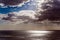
[39, 0, 60, 21]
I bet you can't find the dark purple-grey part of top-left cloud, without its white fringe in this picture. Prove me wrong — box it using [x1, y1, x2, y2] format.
[0, 0, 27, 5]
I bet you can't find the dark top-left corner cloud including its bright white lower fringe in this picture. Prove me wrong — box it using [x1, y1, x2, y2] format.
[0, 0, 30, 8]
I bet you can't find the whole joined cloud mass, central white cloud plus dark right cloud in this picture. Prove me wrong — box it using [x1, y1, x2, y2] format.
[2, 0, 60, 23]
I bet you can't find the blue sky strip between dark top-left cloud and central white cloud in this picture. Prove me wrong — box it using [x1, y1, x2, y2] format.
[0, 0, 36, 14]
